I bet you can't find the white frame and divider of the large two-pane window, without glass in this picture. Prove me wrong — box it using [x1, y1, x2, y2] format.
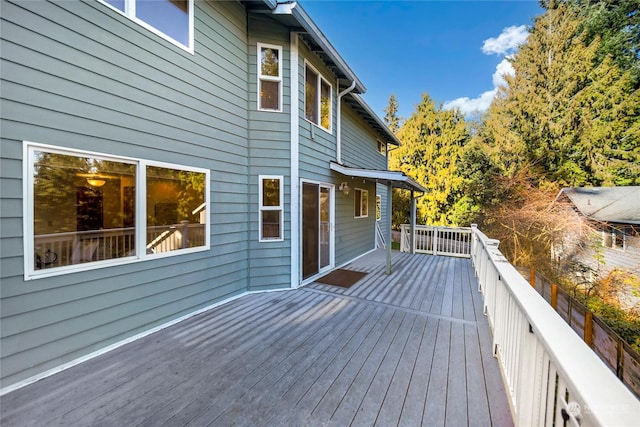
[22, 141, 211, 281]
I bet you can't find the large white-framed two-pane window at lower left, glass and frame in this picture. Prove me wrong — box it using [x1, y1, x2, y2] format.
[24, 144, 209, 278]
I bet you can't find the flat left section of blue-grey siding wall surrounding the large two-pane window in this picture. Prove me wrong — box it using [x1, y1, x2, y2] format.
[0, 1, 252, 387]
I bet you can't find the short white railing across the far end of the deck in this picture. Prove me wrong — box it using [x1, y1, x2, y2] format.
[400, 224, 471, 258]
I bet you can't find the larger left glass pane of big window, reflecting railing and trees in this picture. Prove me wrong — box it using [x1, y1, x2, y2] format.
[33, 151, 136, 270]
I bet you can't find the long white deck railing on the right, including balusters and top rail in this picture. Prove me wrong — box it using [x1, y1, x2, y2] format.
[472, 226, 640, 426]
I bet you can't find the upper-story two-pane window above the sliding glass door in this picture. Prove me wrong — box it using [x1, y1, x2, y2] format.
[304, 64, 331, 132]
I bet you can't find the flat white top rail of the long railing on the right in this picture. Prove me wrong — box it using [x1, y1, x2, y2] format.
[472, 226, 640, 425]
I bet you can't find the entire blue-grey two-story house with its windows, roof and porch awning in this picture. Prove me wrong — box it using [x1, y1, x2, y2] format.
[0, 0, 424, 392]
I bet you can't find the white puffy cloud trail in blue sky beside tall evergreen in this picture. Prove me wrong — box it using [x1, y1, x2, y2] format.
[442, 25, 529, 116]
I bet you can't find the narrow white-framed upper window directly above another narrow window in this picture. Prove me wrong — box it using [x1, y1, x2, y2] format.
[258, 43, 282, 111]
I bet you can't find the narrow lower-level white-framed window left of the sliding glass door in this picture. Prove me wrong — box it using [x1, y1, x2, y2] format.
[258, 175, 284, 242]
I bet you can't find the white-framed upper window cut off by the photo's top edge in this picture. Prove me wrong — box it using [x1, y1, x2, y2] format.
[100, 0, 193, 52]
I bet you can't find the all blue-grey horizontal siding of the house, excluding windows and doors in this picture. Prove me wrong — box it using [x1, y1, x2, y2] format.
[0, 0, 400, 388]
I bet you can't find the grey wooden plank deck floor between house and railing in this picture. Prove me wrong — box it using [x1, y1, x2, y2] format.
[0, 252, 512, 427]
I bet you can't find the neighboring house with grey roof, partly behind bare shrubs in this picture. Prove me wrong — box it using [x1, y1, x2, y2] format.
[552, 187, 640, 300]
